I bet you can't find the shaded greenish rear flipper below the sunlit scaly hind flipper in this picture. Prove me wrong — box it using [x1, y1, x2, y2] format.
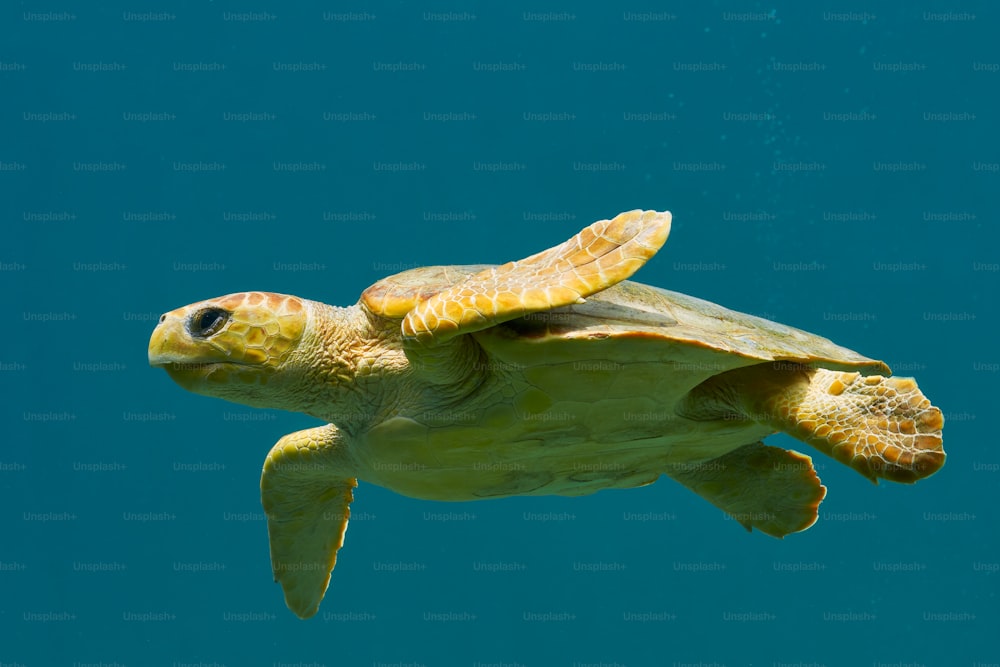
[666, 442, 826, 537]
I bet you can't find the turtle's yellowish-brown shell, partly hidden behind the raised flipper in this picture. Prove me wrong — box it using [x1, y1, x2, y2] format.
[361, 265, 890, 375]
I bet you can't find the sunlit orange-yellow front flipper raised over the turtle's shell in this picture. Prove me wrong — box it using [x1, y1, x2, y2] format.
[403, 211, 670, 345]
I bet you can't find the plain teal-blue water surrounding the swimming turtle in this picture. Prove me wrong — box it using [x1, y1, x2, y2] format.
[0, 1, 1000, 667]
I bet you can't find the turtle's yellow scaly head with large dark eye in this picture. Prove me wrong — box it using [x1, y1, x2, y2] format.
[149, 292, 310, 408]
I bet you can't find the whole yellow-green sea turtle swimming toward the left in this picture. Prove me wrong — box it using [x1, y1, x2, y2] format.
[149, 211, 945, 618]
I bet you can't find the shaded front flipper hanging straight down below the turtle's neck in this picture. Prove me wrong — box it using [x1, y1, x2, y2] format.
[260, 425, 358, 618]
